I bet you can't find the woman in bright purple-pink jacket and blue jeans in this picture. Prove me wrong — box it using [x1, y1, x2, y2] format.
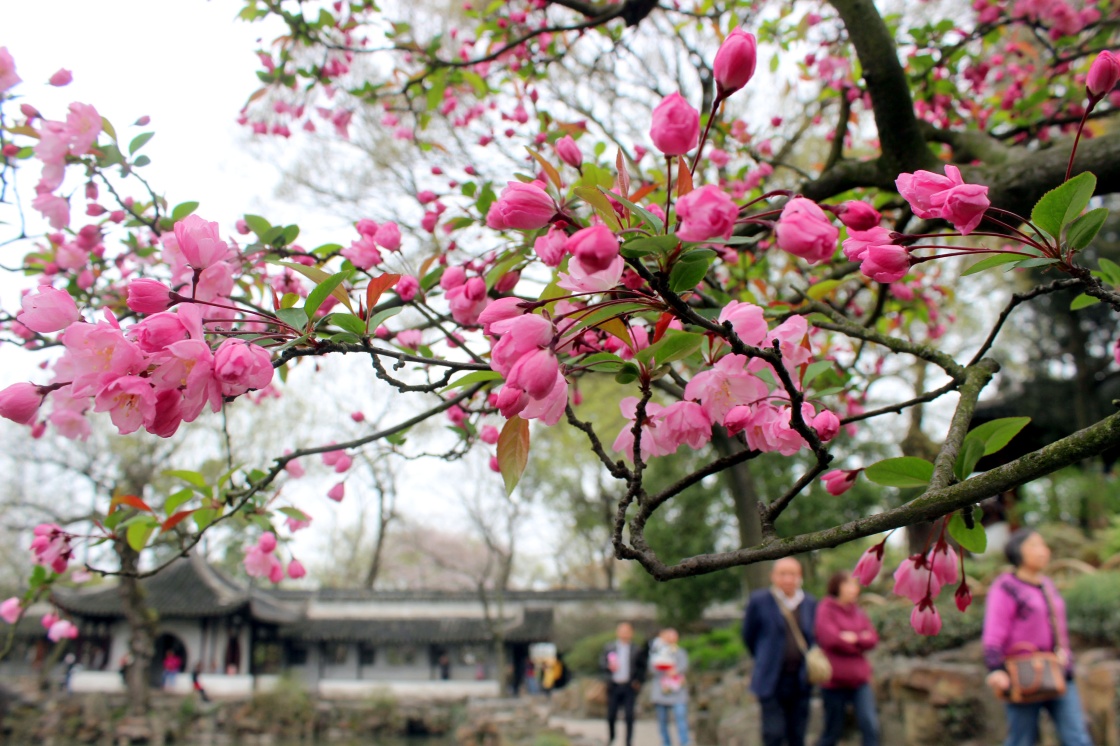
[982, 529, 1092, 746]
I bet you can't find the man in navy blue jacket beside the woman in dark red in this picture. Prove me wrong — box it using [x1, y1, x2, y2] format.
[743, 557, 816, 746]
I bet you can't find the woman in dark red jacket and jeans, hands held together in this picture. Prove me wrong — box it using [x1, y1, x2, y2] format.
[814, 570, 879, 746]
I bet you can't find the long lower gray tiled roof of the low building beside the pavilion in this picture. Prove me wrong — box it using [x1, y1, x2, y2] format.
[280, 608, 552, 645]
